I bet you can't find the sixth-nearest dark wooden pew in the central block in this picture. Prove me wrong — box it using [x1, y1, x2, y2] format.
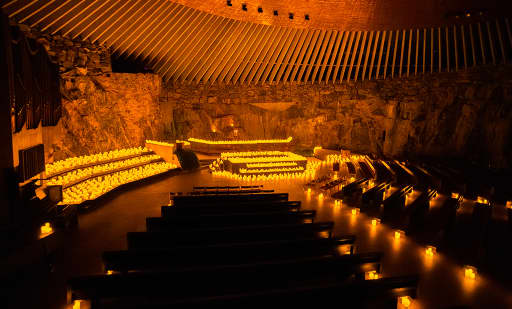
[173, 193, 288, 206]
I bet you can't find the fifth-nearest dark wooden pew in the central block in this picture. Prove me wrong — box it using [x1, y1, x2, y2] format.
[161, 201, 301, 217]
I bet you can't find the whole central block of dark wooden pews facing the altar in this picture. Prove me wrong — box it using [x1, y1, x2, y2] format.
[68, 189, 419, 308]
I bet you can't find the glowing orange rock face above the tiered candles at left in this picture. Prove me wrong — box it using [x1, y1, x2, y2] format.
[45, 73, 162, 162]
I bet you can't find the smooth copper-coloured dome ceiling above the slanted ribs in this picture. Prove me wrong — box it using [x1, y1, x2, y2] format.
[171, 0, 512, 31]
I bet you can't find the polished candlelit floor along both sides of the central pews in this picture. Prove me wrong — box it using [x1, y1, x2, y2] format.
[10, 170, 512, 309]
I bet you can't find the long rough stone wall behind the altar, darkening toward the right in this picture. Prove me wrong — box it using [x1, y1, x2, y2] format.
[160, 67, 512, 166]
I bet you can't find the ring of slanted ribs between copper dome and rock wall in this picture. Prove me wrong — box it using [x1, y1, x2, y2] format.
[2, 0, 512, 83]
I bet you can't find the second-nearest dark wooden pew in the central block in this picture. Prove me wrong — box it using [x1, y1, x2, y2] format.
[103, 235, 355, 272]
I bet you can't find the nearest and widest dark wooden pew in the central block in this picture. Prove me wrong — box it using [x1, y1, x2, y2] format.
[78, 276, 419, 309]
